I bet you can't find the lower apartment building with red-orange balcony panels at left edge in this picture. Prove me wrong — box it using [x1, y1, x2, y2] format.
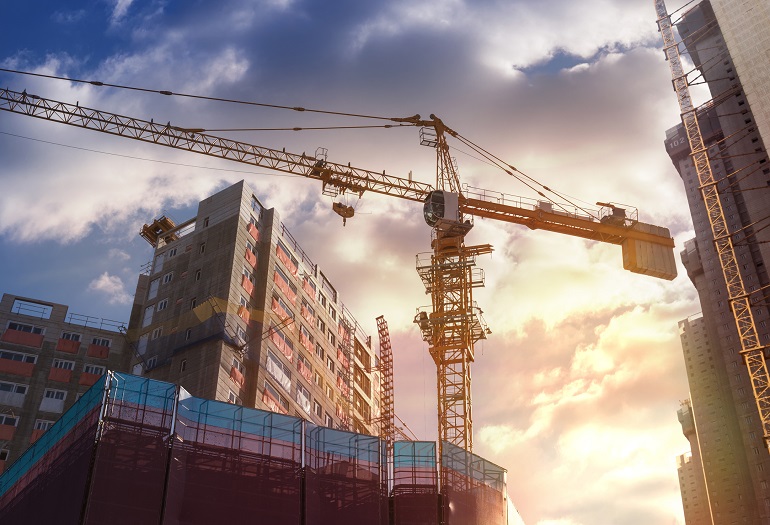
[0, 294, 131, 471]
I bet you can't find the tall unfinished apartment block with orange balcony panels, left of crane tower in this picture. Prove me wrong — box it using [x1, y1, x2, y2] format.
[129, 181, 380, 434]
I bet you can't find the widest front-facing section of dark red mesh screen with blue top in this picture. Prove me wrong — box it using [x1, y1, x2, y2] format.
[163, 398, 302, 525]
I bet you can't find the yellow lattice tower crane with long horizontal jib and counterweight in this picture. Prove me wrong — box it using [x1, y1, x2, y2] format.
[0, 83, 676, 460]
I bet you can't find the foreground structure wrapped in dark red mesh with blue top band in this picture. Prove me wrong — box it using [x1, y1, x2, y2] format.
[0, 372, 507, 525]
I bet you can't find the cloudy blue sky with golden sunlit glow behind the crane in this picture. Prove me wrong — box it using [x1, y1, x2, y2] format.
[0, 0, 700, 525]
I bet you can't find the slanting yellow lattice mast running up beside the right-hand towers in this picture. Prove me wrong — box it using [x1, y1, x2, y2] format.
[655, 0, 770, 448]
